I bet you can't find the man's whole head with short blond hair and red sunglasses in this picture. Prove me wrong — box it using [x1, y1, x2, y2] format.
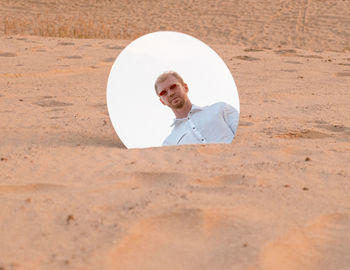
[154, 71, 189, 109]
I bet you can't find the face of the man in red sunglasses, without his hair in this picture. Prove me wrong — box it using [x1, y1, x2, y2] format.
[157, 75, 188, 109]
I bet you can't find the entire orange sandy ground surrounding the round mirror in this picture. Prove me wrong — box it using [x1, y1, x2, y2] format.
[0, 0, 350, 270]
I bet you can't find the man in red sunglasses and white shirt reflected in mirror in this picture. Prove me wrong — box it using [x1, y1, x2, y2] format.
[154, 71, 239, 146]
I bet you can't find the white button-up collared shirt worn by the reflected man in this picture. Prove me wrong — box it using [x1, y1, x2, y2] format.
[163, 102, 239, 146]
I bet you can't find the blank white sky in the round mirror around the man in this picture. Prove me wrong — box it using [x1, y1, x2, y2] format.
[107, 31, 239, 148]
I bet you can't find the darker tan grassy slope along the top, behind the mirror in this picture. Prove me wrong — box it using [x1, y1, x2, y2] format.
[0, 0, 350, 52]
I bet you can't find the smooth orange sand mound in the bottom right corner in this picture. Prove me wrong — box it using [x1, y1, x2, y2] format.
[260, 213, 350, 270]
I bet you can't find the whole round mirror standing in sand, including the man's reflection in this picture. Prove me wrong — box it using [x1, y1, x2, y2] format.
[107, 32, 239, 148]
